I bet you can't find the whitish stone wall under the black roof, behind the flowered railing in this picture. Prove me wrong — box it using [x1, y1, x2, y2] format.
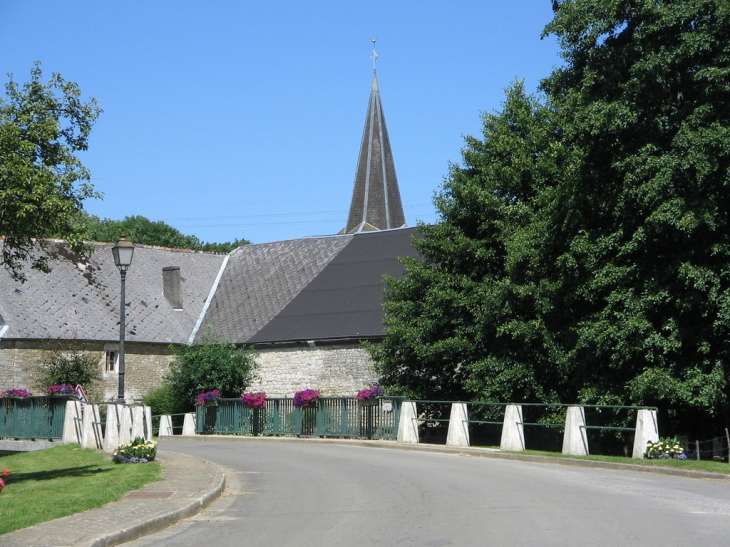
[247, 345, 377, 397]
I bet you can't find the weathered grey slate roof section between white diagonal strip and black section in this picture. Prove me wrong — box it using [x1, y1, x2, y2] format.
[197, 235, 352, 343]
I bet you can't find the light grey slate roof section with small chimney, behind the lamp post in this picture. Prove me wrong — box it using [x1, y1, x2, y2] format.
[0, 241, 226, 343]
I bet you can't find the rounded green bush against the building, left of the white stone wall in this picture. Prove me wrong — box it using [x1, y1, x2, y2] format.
[164, 333, 257, 412]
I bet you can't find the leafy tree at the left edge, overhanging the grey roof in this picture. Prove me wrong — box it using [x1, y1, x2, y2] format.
[0, 63, 101, 280]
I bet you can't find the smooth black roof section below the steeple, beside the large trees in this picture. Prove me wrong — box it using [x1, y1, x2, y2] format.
[248, 228, 418, 343]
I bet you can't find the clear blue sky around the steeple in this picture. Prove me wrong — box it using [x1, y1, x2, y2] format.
[0, 0, 561, 243]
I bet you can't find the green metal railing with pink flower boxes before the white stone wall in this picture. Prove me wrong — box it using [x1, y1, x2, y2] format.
[196, 397, 402, 439]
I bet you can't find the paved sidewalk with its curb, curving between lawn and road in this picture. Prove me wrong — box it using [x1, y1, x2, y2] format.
[0, 450, 225, 547]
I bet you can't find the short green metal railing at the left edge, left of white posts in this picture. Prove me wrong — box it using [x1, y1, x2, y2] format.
[0, 396, 69, 440]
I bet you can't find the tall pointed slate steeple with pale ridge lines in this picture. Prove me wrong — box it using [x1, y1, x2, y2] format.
[341, 68, 406, 234]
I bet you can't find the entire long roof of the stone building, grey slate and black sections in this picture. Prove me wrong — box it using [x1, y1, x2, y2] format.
[0, 228, 417, 344]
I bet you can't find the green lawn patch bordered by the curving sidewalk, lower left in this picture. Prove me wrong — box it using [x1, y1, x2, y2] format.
[0, 444, 160, 534]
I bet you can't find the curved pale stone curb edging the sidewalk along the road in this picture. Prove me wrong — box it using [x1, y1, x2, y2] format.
[80, 456, 226, 547]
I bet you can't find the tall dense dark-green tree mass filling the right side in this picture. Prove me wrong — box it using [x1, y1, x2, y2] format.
[371, 0, 730, 436]
